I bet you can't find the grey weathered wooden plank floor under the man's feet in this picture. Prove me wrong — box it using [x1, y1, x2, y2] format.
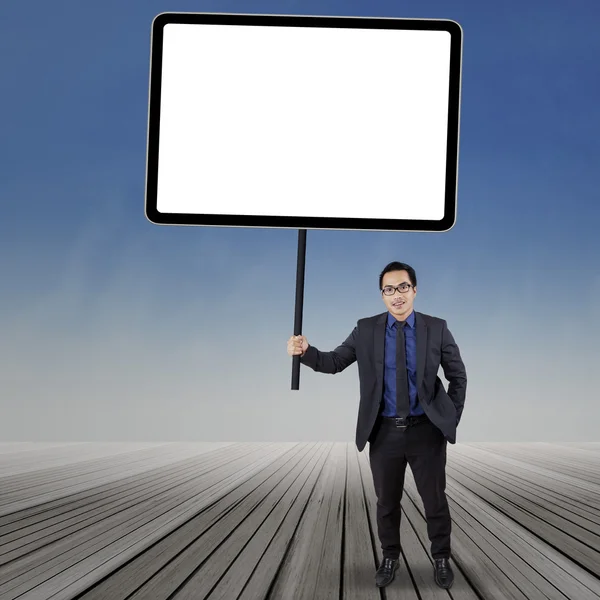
[0, 442, 600, 600]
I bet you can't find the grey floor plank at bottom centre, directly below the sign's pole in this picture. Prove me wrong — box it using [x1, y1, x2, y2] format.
[258, 442, 346, 600]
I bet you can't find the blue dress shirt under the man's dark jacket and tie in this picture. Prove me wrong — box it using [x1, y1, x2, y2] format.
[381, 311, 425, 417]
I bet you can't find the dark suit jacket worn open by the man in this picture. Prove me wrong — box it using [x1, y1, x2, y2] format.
[300, 311, 467, 452]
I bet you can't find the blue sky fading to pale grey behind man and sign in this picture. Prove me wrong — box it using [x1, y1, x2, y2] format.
[0, 0, 600, 441]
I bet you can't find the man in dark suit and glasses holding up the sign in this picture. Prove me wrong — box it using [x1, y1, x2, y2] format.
[287, 262, 467, 589]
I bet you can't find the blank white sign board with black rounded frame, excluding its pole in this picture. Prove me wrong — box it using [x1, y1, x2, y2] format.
[146, 13, 462, 231]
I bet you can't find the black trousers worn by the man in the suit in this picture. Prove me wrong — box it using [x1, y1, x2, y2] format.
[369, 417, 451, 558]
